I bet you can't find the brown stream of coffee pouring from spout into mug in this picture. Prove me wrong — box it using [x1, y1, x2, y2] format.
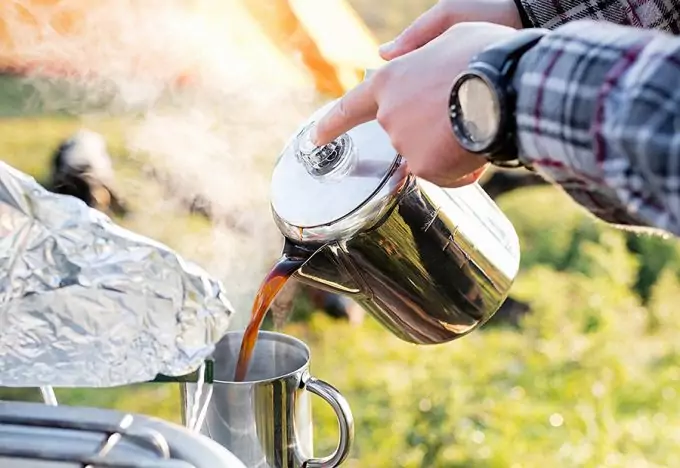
[234, 256, 305, 382]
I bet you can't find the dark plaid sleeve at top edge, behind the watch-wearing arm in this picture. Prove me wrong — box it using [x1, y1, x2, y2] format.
[515, 0, 680, 34]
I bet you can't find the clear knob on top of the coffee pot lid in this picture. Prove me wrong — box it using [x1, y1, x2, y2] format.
[295, 123, 356, 178]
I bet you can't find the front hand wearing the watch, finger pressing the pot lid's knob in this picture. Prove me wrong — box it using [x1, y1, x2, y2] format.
[313, 23, 516, 187]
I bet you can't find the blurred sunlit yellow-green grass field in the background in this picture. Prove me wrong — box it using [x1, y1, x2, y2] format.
[0, 0, 680, 468]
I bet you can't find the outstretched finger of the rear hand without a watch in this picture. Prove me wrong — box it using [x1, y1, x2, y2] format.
[379, 4, 451, 60]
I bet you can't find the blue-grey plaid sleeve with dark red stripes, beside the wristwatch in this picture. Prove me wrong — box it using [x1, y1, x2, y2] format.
[515, 20, 680, 234]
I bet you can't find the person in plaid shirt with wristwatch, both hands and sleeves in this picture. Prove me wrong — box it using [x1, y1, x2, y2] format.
[314, 0, 680, 235]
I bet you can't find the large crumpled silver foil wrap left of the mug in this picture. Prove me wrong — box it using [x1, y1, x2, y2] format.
[0, 161, 233, 387]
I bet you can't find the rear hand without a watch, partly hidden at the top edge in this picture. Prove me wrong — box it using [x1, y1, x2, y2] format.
[380, 0, 522, 60]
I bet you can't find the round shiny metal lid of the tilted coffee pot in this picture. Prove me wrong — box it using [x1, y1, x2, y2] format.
[271, 99, 399, 229]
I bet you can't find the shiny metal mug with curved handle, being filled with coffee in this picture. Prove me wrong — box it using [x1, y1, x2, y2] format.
[182, 331, 354, 468]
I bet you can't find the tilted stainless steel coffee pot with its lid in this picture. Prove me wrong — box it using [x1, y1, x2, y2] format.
[271, 99, 520, 344]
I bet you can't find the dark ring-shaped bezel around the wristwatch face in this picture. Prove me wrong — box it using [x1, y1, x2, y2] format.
[449, 68, 507, 155]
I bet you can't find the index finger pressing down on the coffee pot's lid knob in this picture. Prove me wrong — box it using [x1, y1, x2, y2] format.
[312, 79, 378, 146]
